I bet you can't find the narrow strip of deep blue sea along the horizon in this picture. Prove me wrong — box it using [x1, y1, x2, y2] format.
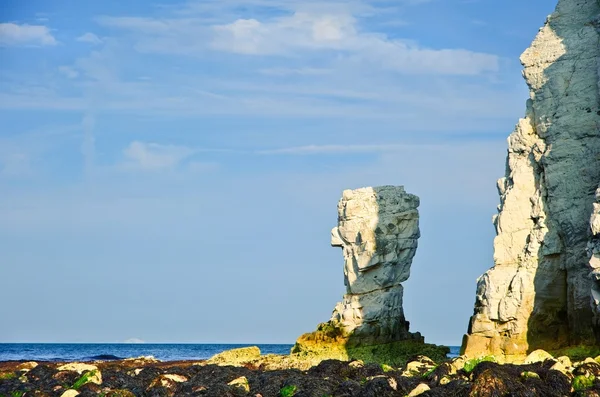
[0, 343, 460, 361]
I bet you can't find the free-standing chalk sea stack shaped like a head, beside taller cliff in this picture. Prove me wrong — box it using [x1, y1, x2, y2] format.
[292, 186, 445, 361]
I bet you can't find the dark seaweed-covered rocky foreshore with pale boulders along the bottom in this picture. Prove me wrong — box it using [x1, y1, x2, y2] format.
[0, 348, 600, 397]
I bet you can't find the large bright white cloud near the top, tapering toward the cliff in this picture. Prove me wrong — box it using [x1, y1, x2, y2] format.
[212, 12, 499, 75]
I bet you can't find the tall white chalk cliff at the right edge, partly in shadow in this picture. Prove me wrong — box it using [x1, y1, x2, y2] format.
[463, 0, 600, 361]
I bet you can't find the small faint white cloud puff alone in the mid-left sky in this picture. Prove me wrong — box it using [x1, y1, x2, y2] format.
[123, 141, 195, 170]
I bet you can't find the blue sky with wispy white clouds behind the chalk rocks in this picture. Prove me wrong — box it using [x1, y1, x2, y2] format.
[0, 0, 555, 345]
